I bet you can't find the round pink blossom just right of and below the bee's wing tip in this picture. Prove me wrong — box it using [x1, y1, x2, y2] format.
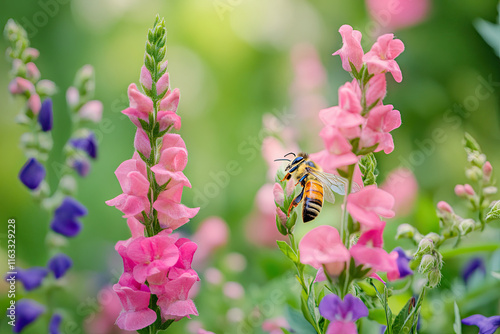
[347, 185, 395, 230]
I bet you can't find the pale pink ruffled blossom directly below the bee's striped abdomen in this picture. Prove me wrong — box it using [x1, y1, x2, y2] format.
[299, 225, 350, 276]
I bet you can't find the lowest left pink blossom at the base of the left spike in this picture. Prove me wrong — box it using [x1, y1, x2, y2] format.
[113, 284, 156, 331]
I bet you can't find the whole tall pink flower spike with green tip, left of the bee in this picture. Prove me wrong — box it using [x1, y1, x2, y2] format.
[106, 17, 199, 333]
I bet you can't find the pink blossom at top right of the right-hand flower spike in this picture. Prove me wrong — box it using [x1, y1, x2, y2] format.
[363, 34, 405, 82]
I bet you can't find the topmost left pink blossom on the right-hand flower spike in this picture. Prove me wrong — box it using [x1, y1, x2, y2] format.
[333, 24, 363, 72]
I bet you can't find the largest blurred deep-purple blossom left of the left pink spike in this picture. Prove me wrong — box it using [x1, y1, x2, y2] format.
[50, 197, 87, 237]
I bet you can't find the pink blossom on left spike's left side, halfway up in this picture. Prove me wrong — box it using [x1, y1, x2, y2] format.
[106, 153, 150, 218]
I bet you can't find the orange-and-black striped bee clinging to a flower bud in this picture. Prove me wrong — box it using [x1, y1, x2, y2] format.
[275, 152, 359, 223]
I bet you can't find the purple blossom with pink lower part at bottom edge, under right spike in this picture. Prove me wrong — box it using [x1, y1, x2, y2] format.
[319, 294, 368, 334]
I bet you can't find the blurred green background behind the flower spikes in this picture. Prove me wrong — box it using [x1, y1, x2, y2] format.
[0, 0, 500, 333]
